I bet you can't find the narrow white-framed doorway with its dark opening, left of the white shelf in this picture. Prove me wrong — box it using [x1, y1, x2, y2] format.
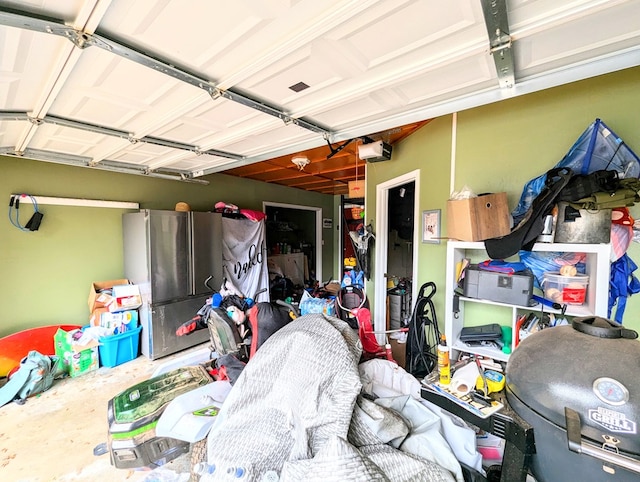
[374, 170, 420, 343]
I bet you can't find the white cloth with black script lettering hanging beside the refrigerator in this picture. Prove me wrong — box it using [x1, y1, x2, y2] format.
[222, 217, 269, 302]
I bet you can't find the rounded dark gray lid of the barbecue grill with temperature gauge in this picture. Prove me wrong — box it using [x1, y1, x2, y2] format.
[506, 317, 640, 454]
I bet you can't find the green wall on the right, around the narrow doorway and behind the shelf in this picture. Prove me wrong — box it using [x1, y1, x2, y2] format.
[367, 67, 640, 336]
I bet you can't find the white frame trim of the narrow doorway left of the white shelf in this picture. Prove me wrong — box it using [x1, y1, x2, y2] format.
[373, 169, 420, 344]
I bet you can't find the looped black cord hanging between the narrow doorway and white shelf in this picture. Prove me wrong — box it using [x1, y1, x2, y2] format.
[406, 282, 440, 378]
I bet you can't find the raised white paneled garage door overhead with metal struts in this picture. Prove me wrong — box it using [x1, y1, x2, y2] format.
[0, 0, 640, 185]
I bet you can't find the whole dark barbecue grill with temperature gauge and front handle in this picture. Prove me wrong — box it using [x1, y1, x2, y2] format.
[506, 317, 640, 482]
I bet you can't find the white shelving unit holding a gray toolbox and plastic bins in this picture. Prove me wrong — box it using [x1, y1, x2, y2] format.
[445, 241, 611, 361]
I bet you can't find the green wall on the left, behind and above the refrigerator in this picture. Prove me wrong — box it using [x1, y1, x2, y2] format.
[0, 156, 339, 336]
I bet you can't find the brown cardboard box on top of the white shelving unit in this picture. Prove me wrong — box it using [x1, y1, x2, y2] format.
[447, 192, 511, 241]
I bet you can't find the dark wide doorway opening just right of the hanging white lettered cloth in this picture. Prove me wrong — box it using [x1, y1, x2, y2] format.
[262, 201, 322, 302]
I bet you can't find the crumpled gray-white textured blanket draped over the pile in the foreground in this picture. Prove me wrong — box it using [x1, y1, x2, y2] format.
[200, 314, 455, 482]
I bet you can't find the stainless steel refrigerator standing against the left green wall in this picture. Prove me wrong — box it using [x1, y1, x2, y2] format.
[122, 209, 222, 360]
